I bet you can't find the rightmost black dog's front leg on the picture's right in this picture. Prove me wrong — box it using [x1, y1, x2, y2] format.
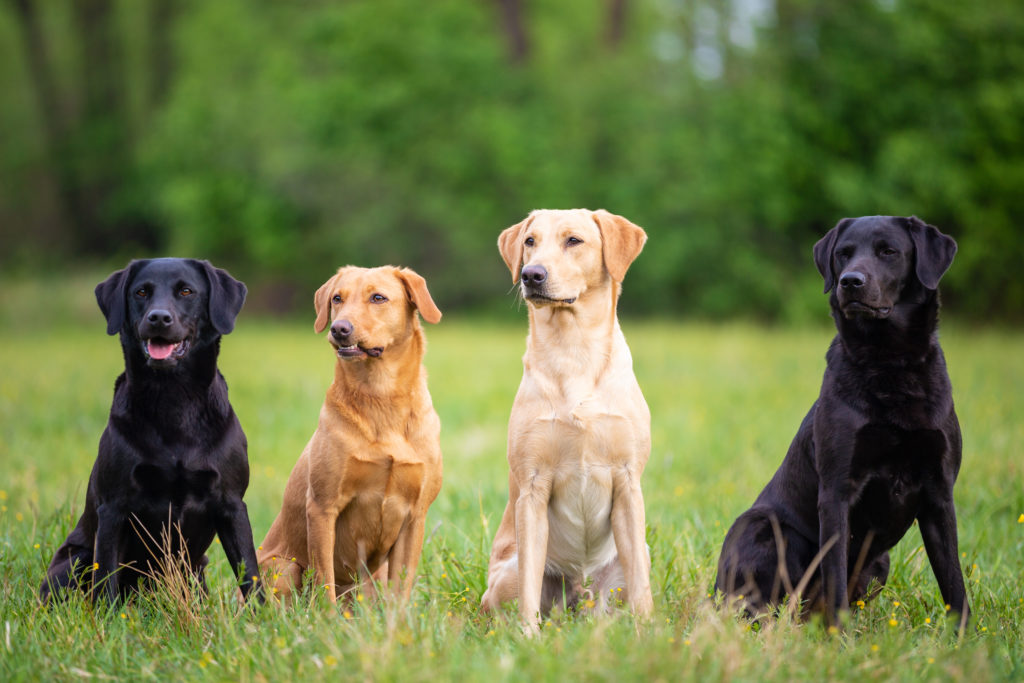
[918, 486, 970, 628]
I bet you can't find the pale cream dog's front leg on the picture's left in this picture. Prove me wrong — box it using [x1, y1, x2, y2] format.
[515, 471, 551, 635]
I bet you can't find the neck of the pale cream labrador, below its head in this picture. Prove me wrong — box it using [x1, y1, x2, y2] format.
[523, 279, 625, 386]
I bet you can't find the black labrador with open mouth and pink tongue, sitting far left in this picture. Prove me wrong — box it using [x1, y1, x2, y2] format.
[39, 258, 262, 601]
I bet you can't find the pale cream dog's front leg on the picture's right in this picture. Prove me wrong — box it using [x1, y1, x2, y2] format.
[611, 466, 654, 616]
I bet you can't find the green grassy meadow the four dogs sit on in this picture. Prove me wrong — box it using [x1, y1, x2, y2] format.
[0, 311, 1024, 681]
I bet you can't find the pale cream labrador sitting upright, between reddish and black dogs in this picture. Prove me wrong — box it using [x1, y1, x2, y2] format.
[481, 209, 653, 634]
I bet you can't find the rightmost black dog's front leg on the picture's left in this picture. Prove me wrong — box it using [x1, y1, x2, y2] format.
[818, 488, 850, 628]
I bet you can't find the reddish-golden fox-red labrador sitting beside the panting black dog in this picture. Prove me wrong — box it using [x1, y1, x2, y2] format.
[259, 266, 441, 603]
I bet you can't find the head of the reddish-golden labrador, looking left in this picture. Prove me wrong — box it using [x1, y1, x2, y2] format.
[313, 265, 441, 360]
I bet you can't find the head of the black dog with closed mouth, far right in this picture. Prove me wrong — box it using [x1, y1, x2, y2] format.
[814, 216, 956, 318]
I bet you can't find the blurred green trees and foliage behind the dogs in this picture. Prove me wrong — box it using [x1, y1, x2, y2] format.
[0, 0, 1024, 323]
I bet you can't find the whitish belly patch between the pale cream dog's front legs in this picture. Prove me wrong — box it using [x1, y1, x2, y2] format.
[547, 466, 615, 577]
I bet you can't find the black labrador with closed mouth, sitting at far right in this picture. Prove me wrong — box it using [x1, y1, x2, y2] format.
[715, 216, 968, 626]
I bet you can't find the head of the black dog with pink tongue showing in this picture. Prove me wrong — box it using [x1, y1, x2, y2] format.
[96, 258, 246, 368]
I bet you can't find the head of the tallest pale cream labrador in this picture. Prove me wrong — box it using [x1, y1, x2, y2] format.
[498, 209, 647, 306]
